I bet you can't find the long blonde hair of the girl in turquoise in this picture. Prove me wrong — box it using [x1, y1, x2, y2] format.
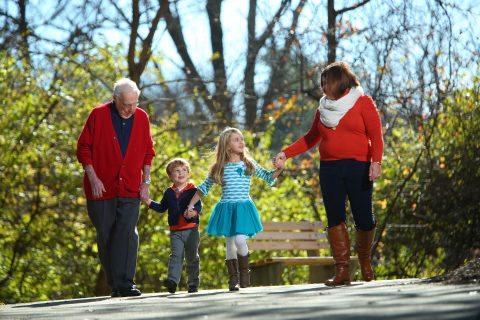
[209, 127, 255, 185]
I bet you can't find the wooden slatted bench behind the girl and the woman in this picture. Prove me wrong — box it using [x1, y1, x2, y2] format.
[248, 221, 358, 285]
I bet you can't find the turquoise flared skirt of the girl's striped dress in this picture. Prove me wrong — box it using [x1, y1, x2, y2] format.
[207, 200, 263, 237]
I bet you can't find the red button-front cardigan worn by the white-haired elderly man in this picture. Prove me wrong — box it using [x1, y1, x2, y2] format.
[77, 102, 155, 200]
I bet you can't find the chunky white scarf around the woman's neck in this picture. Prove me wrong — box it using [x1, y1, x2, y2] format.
[318, 86, 363, 128]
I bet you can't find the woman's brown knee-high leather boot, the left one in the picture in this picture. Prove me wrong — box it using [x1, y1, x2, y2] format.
[325, 222, 350, 286]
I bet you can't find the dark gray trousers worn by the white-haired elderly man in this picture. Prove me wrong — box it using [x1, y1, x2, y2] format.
[87, 198, 140, 289]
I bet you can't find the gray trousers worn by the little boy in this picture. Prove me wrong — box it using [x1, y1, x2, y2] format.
[168, 228, 200, 287]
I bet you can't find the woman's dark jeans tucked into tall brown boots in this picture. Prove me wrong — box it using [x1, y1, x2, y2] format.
[320, 159, 375, 231]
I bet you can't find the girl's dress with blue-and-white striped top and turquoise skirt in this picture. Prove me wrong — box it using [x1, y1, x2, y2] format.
[198, 161, 276, 237]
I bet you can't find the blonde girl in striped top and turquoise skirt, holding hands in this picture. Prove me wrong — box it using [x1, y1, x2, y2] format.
[186, 128, 281, 291]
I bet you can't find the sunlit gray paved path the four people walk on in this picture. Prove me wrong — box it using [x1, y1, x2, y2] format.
[0, 279, 480, 320]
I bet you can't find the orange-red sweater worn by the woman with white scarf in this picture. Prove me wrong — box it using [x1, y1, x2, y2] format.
[283, 96, 383, 162]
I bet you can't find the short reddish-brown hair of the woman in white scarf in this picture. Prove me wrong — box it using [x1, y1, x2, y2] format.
[320, 61, 360, 100]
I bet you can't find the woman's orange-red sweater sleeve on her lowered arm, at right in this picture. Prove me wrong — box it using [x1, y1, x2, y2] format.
[362, 97, 383, 162]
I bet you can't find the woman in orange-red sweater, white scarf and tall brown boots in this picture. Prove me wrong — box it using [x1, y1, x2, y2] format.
[274, 61, 383, 286]
